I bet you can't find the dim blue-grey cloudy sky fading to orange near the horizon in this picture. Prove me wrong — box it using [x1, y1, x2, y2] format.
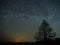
[0, 0, 60, 42]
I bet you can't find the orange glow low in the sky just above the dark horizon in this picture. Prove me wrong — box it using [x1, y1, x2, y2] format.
[12, 33, 30, 42]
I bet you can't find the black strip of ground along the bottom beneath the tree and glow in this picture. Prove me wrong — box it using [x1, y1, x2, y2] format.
[0, 40, 60, 45]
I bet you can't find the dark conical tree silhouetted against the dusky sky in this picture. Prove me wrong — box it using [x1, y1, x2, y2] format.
[35, 19, 56, 41]
